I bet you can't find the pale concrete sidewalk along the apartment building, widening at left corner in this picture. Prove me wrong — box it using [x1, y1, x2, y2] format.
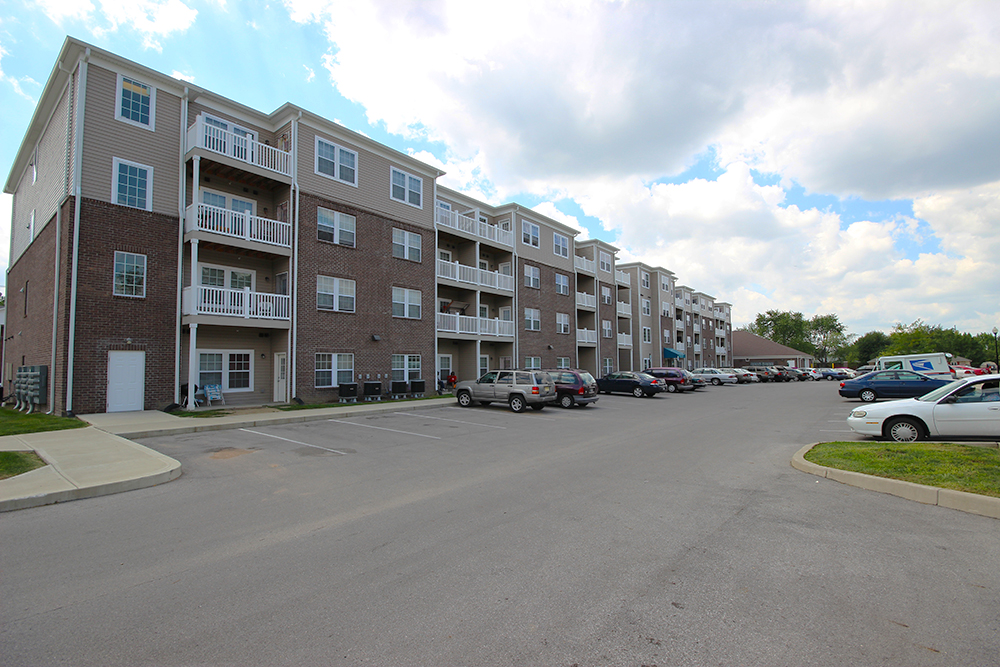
[0, 396, 455, 512]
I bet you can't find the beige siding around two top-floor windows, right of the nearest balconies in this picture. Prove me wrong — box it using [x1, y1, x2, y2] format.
[298, 123, 434, 229]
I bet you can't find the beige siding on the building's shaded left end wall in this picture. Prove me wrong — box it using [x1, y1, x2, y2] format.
[10, 78, 73, 263]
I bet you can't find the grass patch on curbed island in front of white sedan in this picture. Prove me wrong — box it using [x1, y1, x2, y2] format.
[805, 441, 1000, 498]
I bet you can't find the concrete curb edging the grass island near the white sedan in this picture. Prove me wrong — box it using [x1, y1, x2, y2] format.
[792, 443, 1000, 519]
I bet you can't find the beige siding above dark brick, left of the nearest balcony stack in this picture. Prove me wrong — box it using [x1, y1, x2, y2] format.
[82, 64, 181, 216]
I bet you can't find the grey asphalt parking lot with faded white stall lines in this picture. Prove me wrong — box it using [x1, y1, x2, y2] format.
[0, 382, 1000, 665]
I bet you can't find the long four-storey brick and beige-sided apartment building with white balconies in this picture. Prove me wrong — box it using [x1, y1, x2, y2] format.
[4, 39, 729, 413]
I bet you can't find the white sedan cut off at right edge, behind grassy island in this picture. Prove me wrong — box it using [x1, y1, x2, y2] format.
[847, 375, 1000, 442]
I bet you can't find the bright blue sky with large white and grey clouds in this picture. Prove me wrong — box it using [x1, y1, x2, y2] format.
[0, 0, 1000, 334]
